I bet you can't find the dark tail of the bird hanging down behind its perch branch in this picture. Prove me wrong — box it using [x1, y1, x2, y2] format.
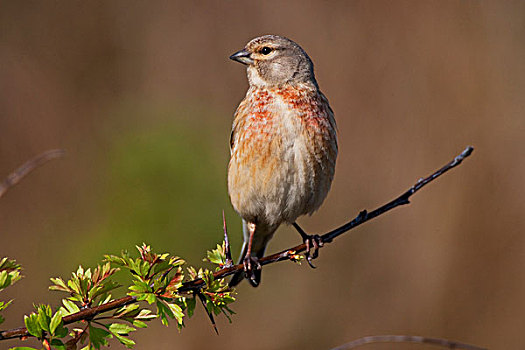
[229, 220, 277, 287]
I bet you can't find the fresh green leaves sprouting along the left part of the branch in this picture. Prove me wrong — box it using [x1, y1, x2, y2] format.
[4, 243, 235, 350]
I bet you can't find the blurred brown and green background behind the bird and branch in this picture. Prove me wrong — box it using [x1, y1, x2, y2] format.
[0, 1, 525, 349]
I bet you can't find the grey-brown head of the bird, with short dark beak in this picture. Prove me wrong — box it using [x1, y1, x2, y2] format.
[230, 35, 317, 86]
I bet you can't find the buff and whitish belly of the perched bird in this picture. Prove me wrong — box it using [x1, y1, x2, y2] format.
[228, 130, 333, 225]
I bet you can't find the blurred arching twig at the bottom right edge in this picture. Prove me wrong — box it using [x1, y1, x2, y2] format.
[332, 335, 486, 350]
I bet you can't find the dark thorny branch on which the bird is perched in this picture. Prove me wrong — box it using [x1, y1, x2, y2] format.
[0, 146, 477, 342]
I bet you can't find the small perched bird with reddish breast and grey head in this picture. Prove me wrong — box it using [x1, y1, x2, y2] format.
[228, 35, 337, 287]
